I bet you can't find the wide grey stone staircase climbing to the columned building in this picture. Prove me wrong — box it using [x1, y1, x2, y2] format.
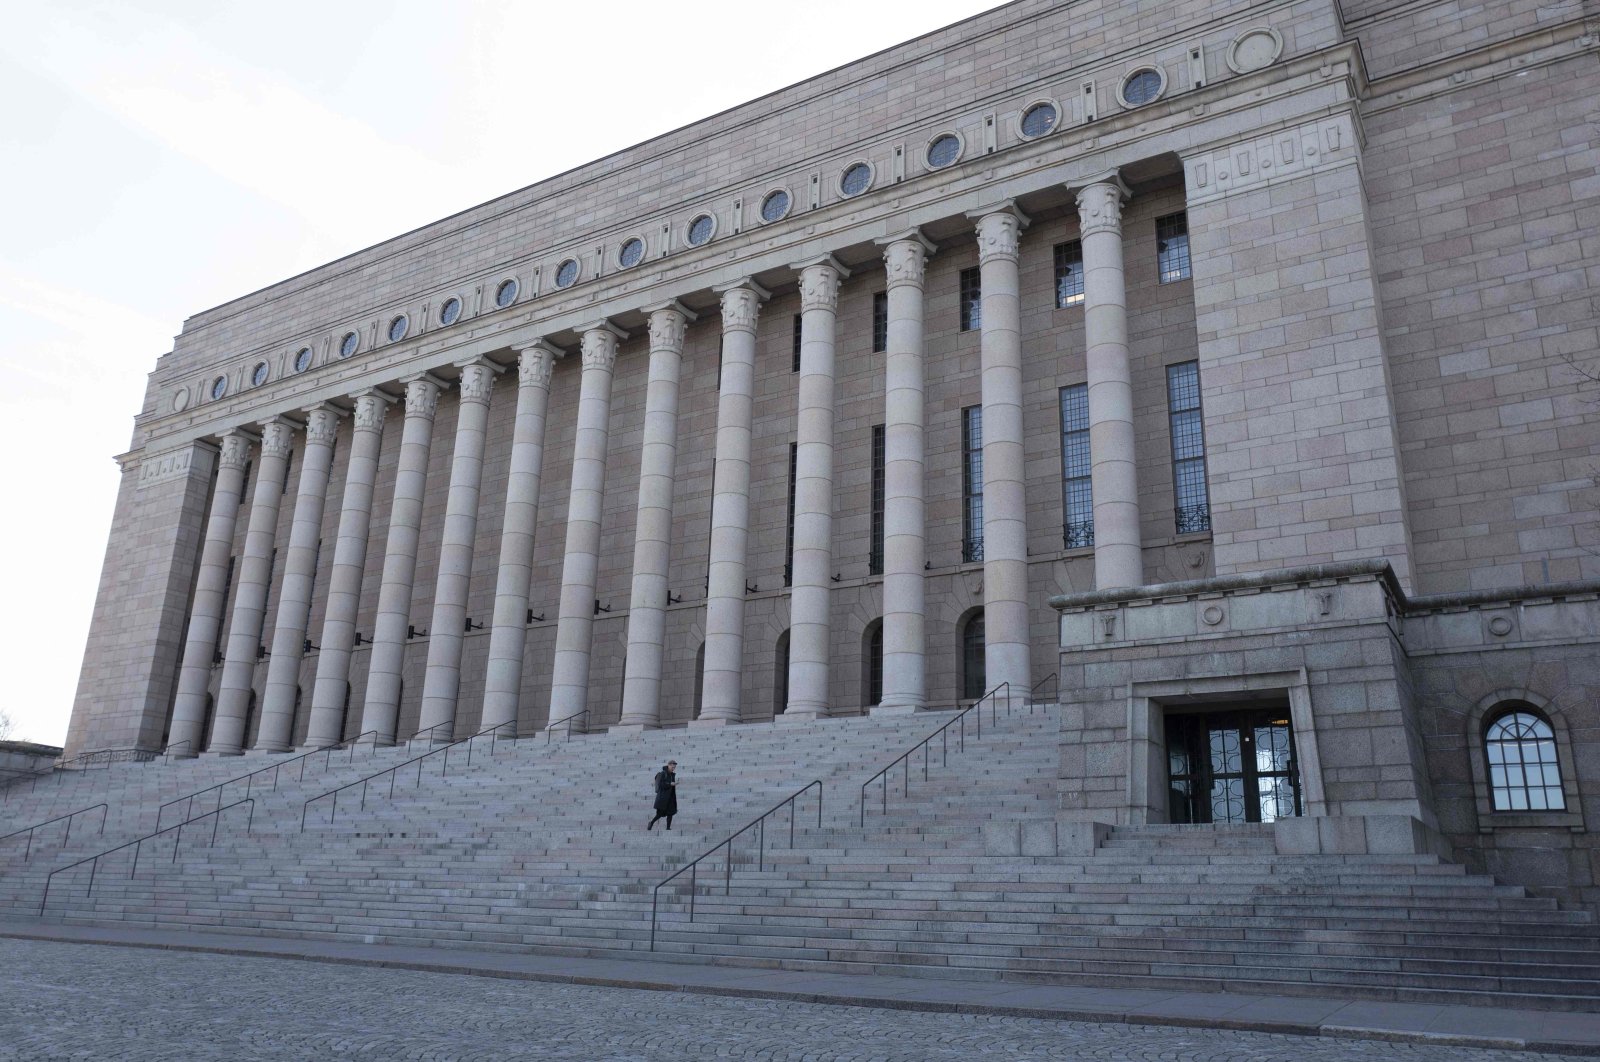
[0, 709, 1600, 1011]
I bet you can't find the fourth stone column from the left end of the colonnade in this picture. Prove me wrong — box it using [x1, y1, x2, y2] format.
[306, 390, 395, 749]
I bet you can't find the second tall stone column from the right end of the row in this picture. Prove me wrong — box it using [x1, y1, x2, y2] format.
[978, 203, 1032, 697]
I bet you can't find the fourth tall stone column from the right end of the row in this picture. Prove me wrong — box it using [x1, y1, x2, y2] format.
[781, 254, 850, 721]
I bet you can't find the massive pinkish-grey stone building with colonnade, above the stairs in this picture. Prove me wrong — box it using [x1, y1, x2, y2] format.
[69, 0, 1600, 902]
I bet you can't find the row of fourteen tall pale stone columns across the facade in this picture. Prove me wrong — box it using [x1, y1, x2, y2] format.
[171, 176, 1142, 752]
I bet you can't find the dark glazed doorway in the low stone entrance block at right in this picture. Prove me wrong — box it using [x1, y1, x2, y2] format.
[1166, 705, 1302, 822]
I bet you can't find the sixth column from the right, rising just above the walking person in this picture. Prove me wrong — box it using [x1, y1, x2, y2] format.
[618, 302, 694, 728]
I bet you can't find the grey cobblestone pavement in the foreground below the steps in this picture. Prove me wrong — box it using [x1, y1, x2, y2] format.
[0, 940, 1587, 1062]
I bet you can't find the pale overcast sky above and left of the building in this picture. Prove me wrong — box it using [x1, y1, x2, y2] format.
[0, 0, 1000, 744]
